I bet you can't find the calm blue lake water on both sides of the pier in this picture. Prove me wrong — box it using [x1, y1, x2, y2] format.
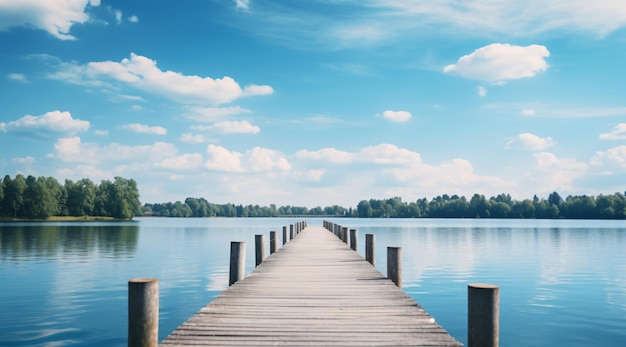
[0, 218, 626, 347]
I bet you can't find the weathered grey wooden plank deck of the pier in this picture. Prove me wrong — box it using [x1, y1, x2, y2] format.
[161, 227, 461, 346]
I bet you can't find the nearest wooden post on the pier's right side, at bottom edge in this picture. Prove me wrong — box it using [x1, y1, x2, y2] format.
[467, 283, 500, 347]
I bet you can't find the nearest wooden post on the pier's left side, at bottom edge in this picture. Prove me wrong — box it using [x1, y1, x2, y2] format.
[128, 278, 159, 347]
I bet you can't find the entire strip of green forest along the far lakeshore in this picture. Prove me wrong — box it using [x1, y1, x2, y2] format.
[0, 174, 626, 219]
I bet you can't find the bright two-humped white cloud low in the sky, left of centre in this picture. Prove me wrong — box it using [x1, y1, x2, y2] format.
[204, 145, 291, 172]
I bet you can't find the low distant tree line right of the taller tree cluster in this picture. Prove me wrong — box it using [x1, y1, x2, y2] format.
[142, 192, 626, 219]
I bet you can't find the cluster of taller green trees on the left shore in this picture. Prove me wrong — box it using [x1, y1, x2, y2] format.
[0, 174, 141, 219]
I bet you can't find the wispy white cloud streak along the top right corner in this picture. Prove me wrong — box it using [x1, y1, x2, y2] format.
[365, 0, 626, 36]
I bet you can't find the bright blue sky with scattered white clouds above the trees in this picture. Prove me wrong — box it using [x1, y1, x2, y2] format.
[0, 0, 626, 207]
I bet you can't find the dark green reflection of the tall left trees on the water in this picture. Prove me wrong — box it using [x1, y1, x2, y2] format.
[0, 223, 139, 260]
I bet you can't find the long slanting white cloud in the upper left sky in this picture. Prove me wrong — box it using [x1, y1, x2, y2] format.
[48, 53, 274, 104]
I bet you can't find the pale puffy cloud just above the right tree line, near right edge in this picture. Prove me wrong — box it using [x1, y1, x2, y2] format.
[530, 152, 589, 194]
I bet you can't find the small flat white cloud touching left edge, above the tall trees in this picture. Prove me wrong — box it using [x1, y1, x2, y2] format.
[0, 111, 89, 136]
